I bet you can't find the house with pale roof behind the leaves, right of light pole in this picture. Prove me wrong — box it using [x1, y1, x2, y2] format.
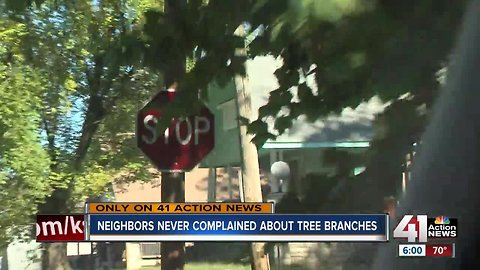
[247, 56, 386, 269]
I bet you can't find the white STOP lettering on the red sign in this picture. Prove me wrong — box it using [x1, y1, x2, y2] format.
[142, 114, 211, 145]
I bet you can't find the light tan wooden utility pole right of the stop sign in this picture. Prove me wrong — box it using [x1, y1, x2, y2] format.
[235, 25, 270, 270]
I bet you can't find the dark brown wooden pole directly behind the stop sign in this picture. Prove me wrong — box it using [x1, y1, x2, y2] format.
[161, 0, 186, 270]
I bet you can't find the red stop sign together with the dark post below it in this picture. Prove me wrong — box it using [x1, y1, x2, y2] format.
[136, 89, 215, 270]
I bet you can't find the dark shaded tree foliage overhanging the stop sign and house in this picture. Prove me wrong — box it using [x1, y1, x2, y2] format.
[6, 0, 466, 239]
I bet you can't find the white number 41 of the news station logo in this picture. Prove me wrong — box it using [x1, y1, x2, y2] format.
[393, 215, 427, 243]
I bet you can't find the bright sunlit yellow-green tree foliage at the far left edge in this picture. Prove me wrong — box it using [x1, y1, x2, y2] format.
[0, 19, 55, 247]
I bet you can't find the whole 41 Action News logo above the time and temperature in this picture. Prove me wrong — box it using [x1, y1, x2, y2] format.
[393, 215, 458, 243]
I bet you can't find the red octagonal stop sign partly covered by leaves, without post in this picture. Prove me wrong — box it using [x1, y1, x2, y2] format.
[136, 91, 215, 171]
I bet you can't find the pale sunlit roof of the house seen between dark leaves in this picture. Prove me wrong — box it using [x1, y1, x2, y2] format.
[247, 56, 386, 148]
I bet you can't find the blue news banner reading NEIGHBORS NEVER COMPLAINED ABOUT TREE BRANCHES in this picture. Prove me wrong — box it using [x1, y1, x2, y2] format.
[86, 214, 389, 242]
